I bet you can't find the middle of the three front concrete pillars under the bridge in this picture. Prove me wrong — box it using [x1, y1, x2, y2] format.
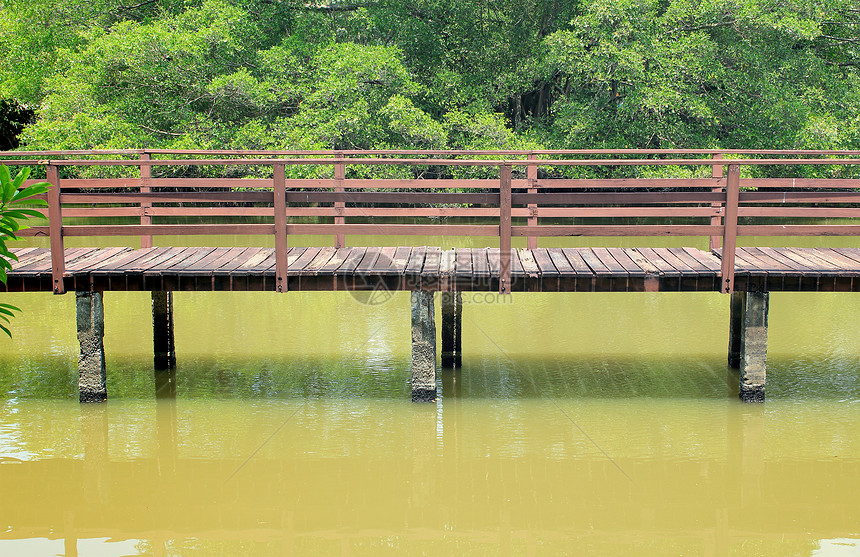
[411, 290, 436, 402]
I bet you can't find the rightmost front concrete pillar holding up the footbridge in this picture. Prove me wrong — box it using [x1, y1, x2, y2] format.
[739, 292, 768, 402]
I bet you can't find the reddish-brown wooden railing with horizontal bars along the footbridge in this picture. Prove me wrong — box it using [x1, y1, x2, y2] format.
[5, 149, 860, 293]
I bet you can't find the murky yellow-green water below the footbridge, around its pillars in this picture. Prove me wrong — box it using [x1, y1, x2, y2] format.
[0, 233, 860, 557]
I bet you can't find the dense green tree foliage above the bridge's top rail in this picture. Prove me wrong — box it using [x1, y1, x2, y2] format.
[0, 0, 860, 155]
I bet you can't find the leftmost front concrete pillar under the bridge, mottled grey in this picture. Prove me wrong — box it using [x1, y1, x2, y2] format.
[75, 292, 107, 402]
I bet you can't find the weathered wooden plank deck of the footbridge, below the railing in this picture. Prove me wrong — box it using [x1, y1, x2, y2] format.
[10, 246, 860, 291]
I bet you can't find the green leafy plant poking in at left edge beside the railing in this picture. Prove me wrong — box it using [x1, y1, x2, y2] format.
[0, 165, 50, 338]
